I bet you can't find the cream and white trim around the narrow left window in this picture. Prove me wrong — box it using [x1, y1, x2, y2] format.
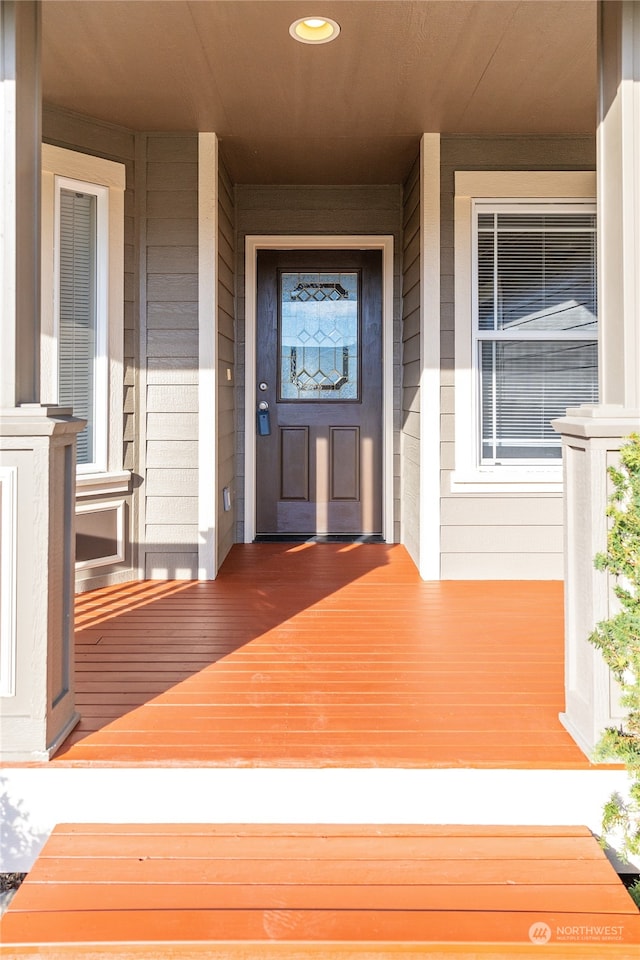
[41, 144, 129, 495]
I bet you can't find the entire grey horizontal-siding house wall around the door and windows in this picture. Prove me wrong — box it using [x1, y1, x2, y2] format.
[37, 119, 594, 589]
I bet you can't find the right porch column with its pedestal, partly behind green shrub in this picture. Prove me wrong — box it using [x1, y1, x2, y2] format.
[553, 0, 640, 753]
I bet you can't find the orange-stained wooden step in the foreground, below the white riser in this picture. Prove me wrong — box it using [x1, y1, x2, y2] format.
[2, 824, 640, 960]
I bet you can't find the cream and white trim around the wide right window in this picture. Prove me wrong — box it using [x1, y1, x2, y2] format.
[451, 170, 596, 493]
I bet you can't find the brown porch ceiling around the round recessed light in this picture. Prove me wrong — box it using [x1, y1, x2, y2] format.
[43, 0, 596, 183]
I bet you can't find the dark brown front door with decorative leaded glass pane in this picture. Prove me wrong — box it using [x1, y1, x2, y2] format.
[256, 250, 382, 536]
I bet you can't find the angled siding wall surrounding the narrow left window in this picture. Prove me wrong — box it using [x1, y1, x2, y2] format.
[42, 106, 138, 590]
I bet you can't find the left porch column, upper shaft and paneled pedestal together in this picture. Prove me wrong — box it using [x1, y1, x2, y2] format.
[0, 0, 83, 762]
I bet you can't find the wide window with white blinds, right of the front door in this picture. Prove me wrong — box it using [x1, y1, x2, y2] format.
[474, 204, 598, 464]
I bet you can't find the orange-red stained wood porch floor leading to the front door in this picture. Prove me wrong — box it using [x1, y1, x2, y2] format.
[53, 544, 589, 769]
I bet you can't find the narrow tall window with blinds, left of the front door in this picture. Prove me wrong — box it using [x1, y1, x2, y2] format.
[58, 189, 97, 464]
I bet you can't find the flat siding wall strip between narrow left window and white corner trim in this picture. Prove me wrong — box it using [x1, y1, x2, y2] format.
[136, 134, 198, 579]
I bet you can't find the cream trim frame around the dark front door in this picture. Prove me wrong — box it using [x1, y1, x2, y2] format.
[244, 234, 394, 543]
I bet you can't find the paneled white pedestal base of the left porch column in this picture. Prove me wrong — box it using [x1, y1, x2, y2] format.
[0, 404, 84, 762]
